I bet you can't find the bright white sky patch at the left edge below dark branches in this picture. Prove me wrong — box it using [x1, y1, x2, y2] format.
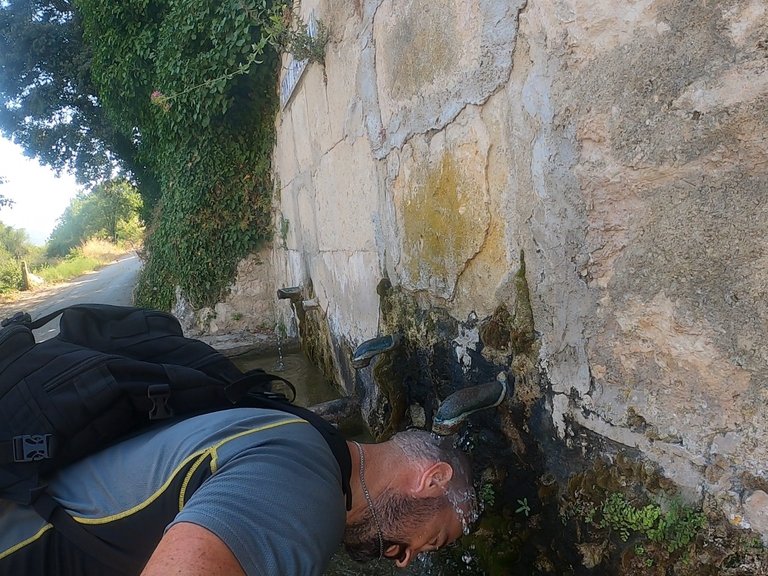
[0, 137, 81, 246]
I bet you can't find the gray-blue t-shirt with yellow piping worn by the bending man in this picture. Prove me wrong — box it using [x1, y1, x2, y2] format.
[0, 408, 346, 576]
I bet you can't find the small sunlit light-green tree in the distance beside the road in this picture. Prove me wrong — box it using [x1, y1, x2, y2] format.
[47, 180, 142, 256]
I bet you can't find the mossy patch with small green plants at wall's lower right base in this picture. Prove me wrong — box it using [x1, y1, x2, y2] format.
[560, 452, 768, 576]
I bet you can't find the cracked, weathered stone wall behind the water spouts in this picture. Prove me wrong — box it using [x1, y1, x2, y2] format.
[260, 0, 768, 533]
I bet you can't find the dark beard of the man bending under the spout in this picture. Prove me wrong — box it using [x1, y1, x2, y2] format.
[344, 490, 445, 562]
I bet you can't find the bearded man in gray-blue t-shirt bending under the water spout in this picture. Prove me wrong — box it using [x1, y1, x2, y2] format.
[0, 408, 475, 576]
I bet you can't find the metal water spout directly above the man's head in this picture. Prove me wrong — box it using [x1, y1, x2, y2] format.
[432, 372, 509, 436]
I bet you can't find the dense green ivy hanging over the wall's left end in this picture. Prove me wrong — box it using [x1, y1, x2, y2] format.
[78, 0, 280, 309]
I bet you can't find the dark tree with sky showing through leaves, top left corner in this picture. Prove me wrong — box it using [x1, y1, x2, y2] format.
[0, 0, 158, 205]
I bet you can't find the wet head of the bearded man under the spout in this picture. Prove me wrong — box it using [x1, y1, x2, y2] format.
[344, 430, 477, 567]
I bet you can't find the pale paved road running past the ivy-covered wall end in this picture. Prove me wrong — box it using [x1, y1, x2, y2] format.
[0, 254, 141, 340]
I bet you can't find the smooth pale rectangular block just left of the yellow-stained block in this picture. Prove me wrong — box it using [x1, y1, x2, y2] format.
[314, 139, 379, 252]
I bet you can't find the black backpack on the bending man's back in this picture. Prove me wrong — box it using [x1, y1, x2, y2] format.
[0, 304, 351, 544]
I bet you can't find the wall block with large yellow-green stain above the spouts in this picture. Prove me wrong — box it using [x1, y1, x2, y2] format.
[393, 108, 491, 298]
